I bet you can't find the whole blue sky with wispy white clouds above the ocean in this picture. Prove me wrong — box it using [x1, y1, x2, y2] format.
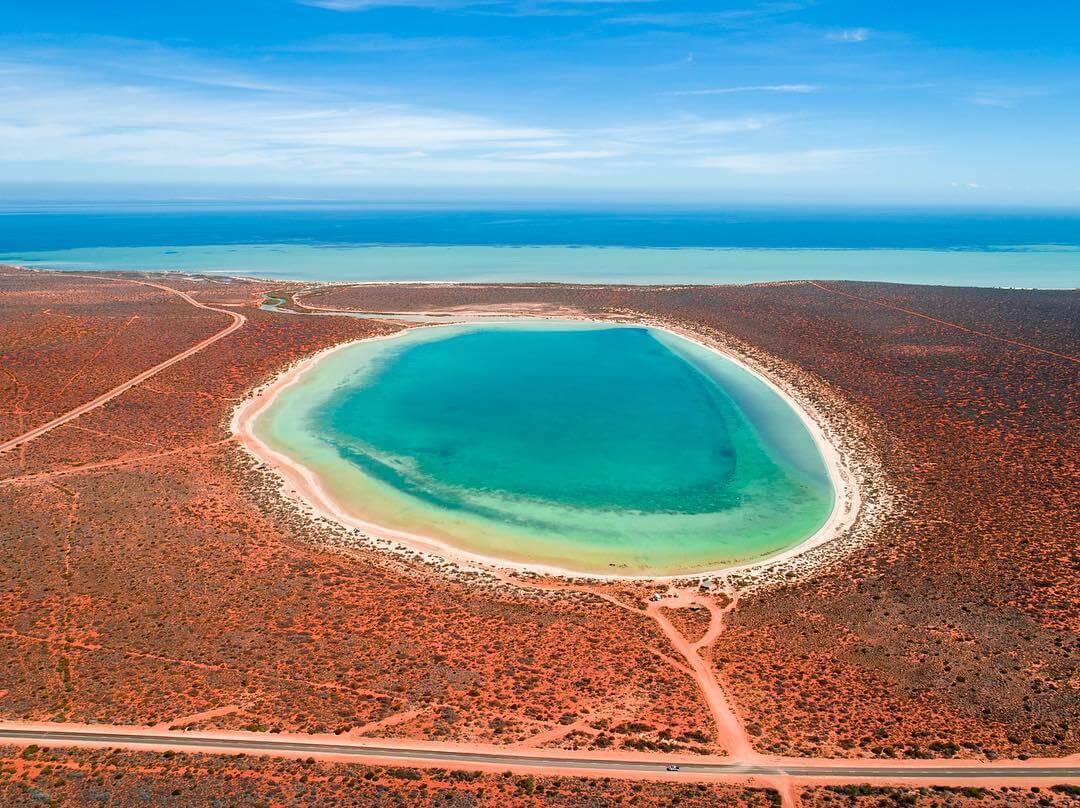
[0, 0, 1080, 205]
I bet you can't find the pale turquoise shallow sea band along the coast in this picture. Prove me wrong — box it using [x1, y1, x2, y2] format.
[0, 244, 1080, 288]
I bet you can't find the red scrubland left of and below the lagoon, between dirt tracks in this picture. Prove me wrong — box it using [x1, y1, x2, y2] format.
[0, 267, 719, 751]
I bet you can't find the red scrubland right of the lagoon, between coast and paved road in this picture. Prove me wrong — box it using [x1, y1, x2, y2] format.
[300, 283, 1080, 757]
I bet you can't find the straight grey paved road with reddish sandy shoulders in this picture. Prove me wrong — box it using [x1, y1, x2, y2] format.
[0, 728, 1080, 783]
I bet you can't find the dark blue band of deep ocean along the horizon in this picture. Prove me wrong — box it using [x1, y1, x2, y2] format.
[0, 206, 1080, 253]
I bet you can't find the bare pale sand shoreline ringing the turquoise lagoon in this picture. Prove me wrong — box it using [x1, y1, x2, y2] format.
[230, 314, 862, 581]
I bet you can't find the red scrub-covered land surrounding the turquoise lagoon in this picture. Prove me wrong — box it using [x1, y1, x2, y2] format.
[0, 268, 1080, 805]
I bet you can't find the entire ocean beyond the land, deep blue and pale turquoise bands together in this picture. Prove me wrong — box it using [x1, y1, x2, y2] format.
[0, 204, 1080, 288]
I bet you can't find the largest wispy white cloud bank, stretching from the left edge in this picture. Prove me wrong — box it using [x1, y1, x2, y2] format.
[0, 46, 782, 177]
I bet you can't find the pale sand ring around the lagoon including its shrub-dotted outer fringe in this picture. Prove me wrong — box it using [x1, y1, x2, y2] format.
[230, 314, 877, 588]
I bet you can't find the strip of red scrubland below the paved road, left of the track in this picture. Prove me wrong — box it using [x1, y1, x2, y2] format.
[0, 746, 780, 808]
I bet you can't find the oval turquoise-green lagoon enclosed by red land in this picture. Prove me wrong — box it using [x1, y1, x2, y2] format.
[255, 322, 834, 575]
